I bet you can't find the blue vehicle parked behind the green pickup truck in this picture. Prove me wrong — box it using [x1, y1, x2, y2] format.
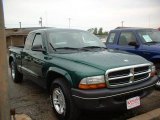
[106, 28, 160, 88]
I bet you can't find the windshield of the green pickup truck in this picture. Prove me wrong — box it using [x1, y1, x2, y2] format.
[48, 30, 105, 49]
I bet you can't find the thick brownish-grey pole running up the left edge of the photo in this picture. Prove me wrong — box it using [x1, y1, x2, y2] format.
[0, 0, 10, 120]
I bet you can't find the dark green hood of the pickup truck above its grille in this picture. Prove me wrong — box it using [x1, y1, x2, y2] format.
[53, 50, 149, 71]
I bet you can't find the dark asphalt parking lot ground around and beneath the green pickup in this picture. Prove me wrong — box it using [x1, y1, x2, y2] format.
[9, 69, 160, 120]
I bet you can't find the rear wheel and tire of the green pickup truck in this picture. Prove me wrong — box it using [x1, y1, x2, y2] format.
[10, 61, 23, 83]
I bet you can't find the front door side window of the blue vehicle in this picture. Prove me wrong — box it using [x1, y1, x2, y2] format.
[118, 32, 137, 45]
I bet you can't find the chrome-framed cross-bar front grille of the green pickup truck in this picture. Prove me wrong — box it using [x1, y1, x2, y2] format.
[106, 64, 151, 87]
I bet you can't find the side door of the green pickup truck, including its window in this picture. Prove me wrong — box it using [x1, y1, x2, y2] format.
[28, 33, 45, 86]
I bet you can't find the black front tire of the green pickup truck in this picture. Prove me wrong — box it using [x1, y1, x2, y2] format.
[50, 78, 80, 120]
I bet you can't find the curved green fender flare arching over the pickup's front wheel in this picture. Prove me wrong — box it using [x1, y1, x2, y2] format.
[47, 67, 73, 85]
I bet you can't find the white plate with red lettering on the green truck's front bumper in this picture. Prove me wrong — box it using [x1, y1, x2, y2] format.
[126, 96, 140, 110]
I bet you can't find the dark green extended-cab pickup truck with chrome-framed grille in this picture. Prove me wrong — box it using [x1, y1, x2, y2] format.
[9, 28, 158, 120]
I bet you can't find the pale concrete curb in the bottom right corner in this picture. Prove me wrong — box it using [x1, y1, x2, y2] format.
[127, 108, 160, 120]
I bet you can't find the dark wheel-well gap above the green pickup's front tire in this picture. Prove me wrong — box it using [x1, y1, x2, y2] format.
[47, 71, 69, 91]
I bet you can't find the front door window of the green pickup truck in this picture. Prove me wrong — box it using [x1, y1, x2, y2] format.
[32, 34, 43, 49]
